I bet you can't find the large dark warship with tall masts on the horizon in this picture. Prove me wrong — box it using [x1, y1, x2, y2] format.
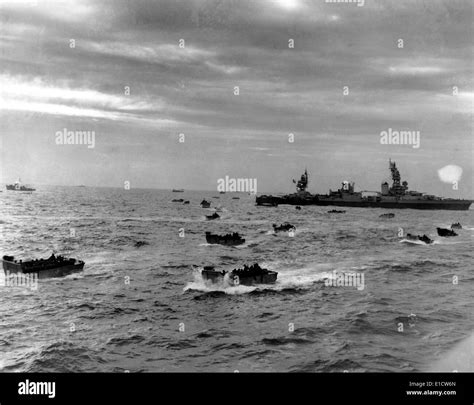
[256, 160, 472, 211]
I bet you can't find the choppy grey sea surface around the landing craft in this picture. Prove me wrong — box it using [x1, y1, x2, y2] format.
[0, 187, 474, 372]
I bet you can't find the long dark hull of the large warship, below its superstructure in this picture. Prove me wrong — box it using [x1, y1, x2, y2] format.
[256, 195, 472, 211]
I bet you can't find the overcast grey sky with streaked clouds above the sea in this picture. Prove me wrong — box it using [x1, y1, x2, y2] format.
[0, 0, 474, 197]
